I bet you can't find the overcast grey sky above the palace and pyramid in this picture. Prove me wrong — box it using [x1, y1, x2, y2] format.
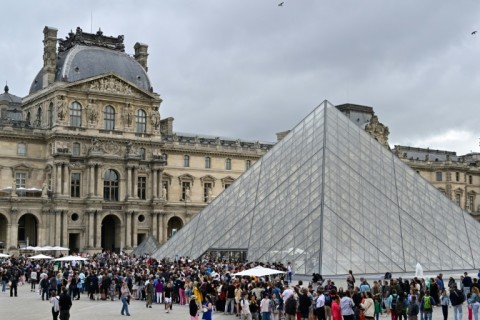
[0, 0, 480, 155]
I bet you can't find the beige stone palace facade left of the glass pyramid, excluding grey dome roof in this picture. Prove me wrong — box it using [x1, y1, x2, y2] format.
[0, 27, 273, 253]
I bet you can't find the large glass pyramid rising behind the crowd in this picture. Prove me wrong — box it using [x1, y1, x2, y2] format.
[154, 101, 480, 275]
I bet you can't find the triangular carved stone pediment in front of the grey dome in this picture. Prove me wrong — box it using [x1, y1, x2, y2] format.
[68, 74, 152, 98]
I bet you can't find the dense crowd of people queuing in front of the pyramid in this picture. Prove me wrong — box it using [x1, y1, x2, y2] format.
[0, 251, 480, 320]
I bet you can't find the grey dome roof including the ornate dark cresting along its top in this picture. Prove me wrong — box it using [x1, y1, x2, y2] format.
[30, 28, 152, 94]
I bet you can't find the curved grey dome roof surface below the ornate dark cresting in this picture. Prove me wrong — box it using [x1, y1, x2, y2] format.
[30, 45, 152, 94]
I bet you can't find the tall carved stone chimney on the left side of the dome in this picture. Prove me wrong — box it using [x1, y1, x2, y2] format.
[43, 26, 58, 88]
